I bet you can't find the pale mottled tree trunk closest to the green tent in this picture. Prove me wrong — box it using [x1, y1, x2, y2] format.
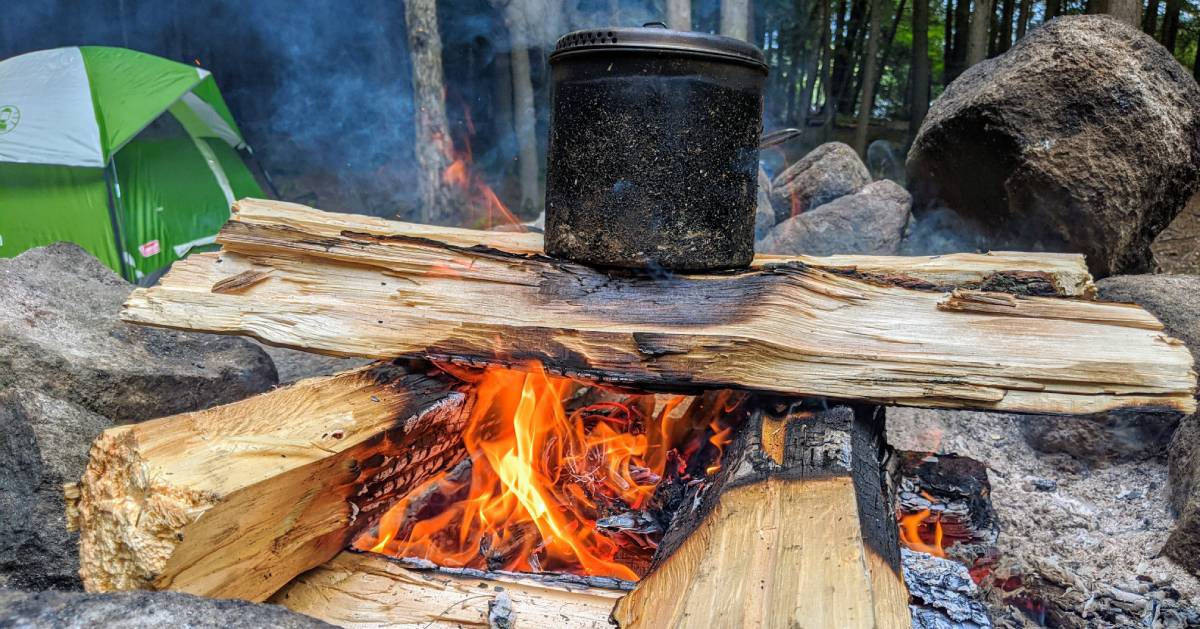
[404, 0, 454, 223]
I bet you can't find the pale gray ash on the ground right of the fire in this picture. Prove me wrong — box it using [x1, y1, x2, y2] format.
[888, 408, 1200, 628]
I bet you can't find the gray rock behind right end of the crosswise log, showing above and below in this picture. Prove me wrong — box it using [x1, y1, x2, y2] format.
[1025, 275, 1200, 463]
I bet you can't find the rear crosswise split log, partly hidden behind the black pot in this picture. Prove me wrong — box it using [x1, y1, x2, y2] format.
[234, 199, 1096, 299]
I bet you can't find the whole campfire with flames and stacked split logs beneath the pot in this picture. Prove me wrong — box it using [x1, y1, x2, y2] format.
[67, 199, 1194, 627]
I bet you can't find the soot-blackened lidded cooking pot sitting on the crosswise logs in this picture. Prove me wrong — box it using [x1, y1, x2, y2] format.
[546, 28, 767, 271]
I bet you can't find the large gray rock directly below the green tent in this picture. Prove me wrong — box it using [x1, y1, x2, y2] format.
[0, 242, 277, 423]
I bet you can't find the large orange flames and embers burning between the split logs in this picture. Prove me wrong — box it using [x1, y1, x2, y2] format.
[354, 364, 732, 580]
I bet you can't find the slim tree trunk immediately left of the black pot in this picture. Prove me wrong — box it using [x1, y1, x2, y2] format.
[504, 0, 541, 216]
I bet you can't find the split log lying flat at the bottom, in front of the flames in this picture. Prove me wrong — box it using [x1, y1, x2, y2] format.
[270, 551, 625, 629]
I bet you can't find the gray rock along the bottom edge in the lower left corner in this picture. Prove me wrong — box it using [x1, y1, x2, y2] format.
[0, 591, 334, 629]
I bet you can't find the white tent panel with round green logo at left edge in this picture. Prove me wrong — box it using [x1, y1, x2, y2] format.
[0, 48, 104, 168]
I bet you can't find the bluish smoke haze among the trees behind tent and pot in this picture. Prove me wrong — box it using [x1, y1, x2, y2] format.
[0, 0, 686, 217]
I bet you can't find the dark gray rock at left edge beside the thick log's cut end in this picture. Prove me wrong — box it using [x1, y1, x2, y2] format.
[0, 389, 110, 589]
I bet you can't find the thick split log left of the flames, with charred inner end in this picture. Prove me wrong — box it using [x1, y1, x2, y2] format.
[67, 364, 468, 601]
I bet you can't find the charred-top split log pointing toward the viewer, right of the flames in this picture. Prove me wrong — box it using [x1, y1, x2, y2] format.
[613, 399, 911, 628]
